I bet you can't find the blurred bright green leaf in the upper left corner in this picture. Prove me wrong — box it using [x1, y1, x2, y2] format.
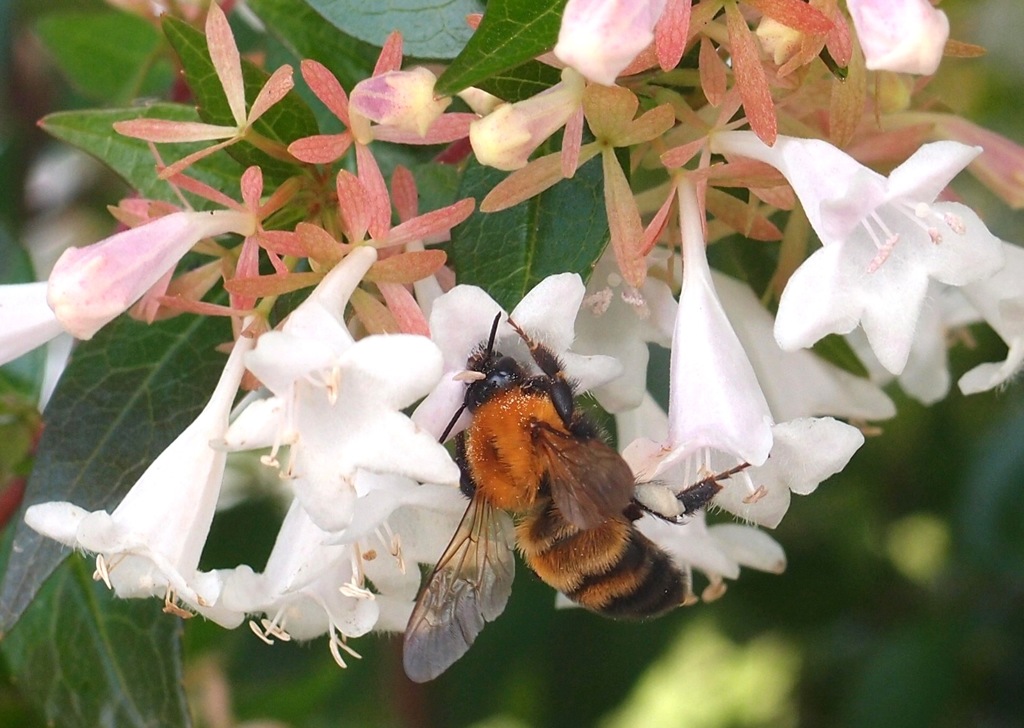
[36, 10, 174, 103]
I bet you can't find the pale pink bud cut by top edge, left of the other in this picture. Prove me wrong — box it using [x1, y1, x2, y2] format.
[555, 0, 666, 86]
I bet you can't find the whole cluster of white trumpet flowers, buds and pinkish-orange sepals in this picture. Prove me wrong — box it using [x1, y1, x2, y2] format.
[8, 0, 1024, 666]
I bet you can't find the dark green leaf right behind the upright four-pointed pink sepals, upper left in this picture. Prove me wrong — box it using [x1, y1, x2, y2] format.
[164, 15, 319, 179]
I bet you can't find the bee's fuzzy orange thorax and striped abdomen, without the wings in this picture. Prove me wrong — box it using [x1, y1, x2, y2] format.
[458, 348, 688, 618]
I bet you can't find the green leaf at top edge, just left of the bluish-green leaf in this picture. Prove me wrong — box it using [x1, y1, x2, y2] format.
[248, 0, 380, 90]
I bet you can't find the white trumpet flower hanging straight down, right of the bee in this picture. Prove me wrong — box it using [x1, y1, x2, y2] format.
[624, 178, 863, 527]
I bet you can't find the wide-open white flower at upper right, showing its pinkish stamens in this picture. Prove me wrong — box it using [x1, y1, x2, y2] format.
[711, 131, 1002, 374]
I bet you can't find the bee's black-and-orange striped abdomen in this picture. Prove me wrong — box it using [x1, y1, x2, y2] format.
[516, 500, 688, 618]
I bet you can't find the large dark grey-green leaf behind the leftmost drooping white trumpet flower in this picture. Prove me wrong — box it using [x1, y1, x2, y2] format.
[0, 315, 230, 633]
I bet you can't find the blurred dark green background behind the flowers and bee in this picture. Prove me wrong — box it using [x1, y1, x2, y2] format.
[0, 0, 1024, 728]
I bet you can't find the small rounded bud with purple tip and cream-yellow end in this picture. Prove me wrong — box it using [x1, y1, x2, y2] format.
[348, 68, 452, 141]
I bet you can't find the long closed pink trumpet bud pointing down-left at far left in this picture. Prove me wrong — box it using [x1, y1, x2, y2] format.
[46, 210, 256, 339]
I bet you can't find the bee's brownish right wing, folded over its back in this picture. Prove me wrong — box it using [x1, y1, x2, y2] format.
[537, 425, 635, 529]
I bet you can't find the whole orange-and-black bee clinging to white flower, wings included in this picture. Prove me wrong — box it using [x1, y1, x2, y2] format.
[403, 314, 745, 682]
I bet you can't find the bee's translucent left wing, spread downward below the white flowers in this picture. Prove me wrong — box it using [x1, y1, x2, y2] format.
[402, 498, 515, 683]
